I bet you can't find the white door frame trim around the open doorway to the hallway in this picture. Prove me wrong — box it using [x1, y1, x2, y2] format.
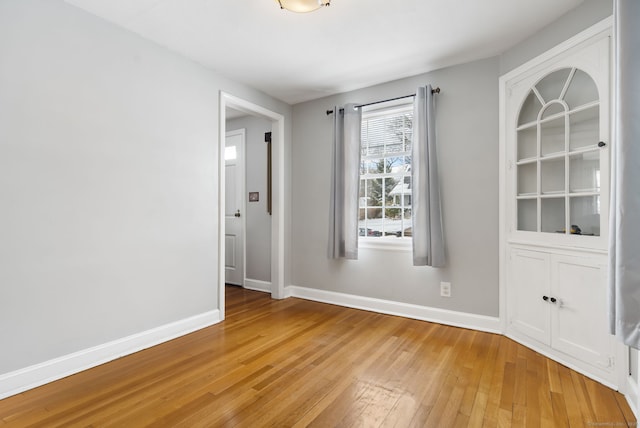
[218, 91, 285, 320]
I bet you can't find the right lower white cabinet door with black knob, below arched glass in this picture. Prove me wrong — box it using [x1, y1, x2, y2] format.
[551, 255, 613, 370]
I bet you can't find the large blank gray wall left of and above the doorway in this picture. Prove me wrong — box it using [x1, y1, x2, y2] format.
[0, 0, 291, 374]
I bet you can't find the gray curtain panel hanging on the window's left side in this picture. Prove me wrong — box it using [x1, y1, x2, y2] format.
[329, 104, 362, 259]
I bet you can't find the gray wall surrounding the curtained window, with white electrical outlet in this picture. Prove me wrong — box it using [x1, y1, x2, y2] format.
[291, 57, 499, 316]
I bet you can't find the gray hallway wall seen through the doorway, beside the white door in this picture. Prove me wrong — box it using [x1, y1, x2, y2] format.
[226, 116, 271, 282]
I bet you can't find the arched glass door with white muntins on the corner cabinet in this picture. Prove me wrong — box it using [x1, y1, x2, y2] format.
[516, 68, 604, 236]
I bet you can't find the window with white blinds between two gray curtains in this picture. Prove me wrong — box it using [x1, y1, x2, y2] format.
[358, 101, 413, 242]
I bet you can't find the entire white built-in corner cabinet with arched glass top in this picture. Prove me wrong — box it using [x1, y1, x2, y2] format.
[500, 19, 621, 387]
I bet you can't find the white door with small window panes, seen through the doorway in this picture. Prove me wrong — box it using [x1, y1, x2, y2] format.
[224, 129, 245, 285]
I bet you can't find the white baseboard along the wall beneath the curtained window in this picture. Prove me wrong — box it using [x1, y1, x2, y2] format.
[285, 285, 502, 334]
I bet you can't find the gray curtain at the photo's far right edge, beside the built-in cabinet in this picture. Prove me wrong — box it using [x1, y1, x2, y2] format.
[609, 0, 640, 348]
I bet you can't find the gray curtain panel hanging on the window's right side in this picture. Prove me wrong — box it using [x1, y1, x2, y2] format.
[411, 85, 445, 267]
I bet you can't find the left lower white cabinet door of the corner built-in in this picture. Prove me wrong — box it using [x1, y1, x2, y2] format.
[509, 250, 550, 345]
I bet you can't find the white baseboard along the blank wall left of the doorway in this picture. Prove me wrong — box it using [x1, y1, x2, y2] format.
[0, 309, 221, 399]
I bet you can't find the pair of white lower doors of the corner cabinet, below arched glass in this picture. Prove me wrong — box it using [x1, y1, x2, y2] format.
[507, 246, 615, 381]
